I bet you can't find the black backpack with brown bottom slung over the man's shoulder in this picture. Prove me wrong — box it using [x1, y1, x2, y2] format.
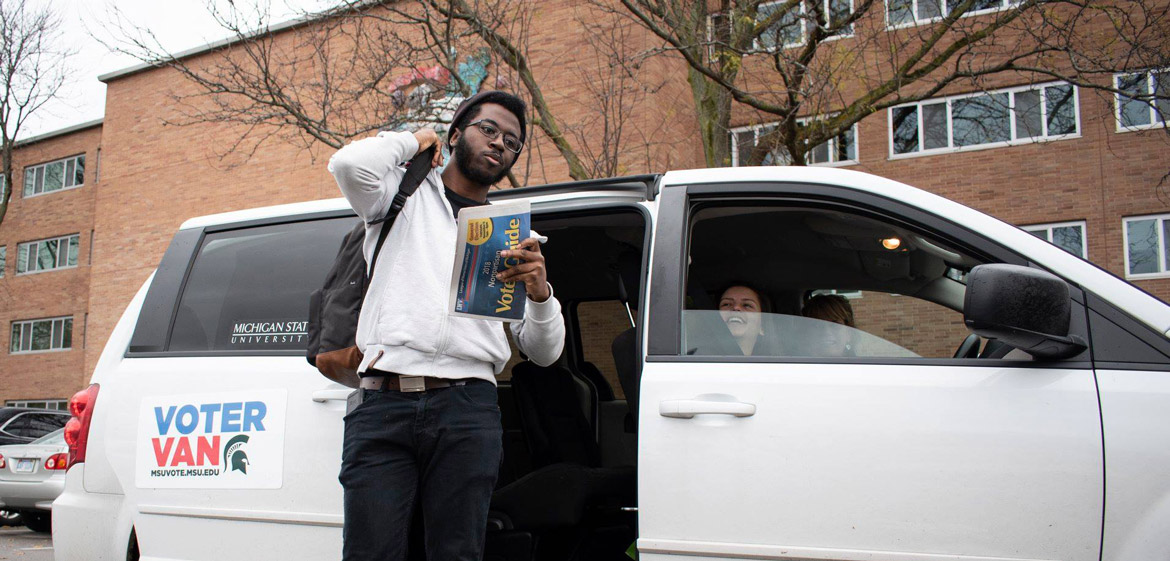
[305, 146, 435, 388]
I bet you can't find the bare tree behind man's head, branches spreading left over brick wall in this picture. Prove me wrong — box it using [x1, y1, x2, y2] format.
[99, 0, 669, 185]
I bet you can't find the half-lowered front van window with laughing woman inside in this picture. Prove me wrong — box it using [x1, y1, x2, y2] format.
[683, 205, 980, 360]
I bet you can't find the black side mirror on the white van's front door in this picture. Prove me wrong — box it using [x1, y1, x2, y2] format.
[963, 264, 1087, 358]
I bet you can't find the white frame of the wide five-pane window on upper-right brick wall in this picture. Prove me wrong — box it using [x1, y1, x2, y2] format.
[886, 82, 1082, 160]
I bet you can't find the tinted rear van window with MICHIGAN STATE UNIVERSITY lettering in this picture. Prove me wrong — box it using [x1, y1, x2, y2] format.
[170, 218, 357, 351]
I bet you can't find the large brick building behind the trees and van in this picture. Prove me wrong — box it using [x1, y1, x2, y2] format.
[0, 0, 1170, 403]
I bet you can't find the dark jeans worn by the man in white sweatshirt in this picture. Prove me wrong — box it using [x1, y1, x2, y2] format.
[339, 379, 502, 561]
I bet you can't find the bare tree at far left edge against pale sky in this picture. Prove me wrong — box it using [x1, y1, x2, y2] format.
[0, 0, 70, 229]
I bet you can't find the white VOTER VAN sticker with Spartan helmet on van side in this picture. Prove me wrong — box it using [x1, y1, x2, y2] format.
[135, 390, 288, 488]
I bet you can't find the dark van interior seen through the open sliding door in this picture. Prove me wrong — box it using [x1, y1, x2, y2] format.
[484, 207, 646, 561]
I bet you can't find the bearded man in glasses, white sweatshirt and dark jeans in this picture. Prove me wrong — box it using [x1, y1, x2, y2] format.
[329, 91, 565, 561]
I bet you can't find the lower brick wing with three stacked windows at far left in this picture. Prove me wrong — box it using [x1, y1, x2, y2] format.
[0, 121, 102, 408]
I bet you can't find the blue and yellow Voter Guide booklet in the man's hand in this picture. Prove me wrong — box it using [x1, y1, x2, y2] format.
[449, 201, 532, 321]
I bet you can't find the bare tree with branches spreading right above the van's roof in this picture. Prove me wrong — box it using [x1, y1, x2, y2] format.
[597, 0, 1170, 166]
